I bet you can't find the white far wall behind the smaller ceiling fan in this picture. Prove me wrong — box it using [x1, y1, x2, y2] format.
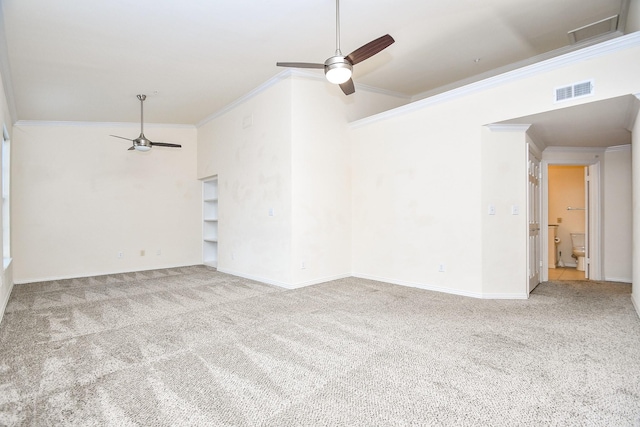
[12, 122, 202, 283]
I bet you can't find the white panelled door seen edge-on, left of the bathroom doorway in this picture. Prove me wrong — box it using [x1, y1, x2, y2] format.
[527, 150, 542, 293]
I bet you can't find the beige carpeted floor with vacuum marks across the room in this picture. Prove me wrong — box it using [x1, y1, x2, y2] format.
[0, 266, 640, 426]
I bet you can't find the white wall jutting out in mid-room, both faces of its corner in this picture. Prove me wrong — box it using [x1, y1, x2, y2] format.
[198, 73, 406, 288]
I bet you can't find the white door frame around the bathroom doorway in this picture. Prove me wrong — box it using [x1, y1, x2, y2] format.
[540, 156, 602, 281]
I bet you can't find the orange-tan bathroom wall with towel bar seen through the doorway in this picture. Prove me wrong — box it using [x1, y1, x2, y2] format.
[548, 165, 585, 267]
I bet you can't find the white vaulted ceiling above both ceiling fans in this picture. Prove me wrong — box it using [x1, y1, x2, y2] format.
[0, 0, 622, 124]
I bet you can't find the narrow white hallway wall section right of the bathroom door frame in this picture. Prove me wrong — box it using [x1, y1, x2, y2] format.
[602, 145, 633, 283]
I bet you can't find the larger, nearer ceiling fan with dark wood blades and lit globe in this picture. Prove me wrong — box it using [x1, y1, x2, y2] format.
[276, 0, 395, 95]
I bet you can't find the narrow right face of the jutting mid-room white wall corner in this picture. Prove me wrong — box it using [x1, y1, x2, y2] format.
[291, 78, 352, 287]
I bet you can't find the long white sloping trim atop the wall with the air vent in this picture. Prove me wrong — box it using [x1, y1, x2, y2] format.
[349, 31, 640, 129]
